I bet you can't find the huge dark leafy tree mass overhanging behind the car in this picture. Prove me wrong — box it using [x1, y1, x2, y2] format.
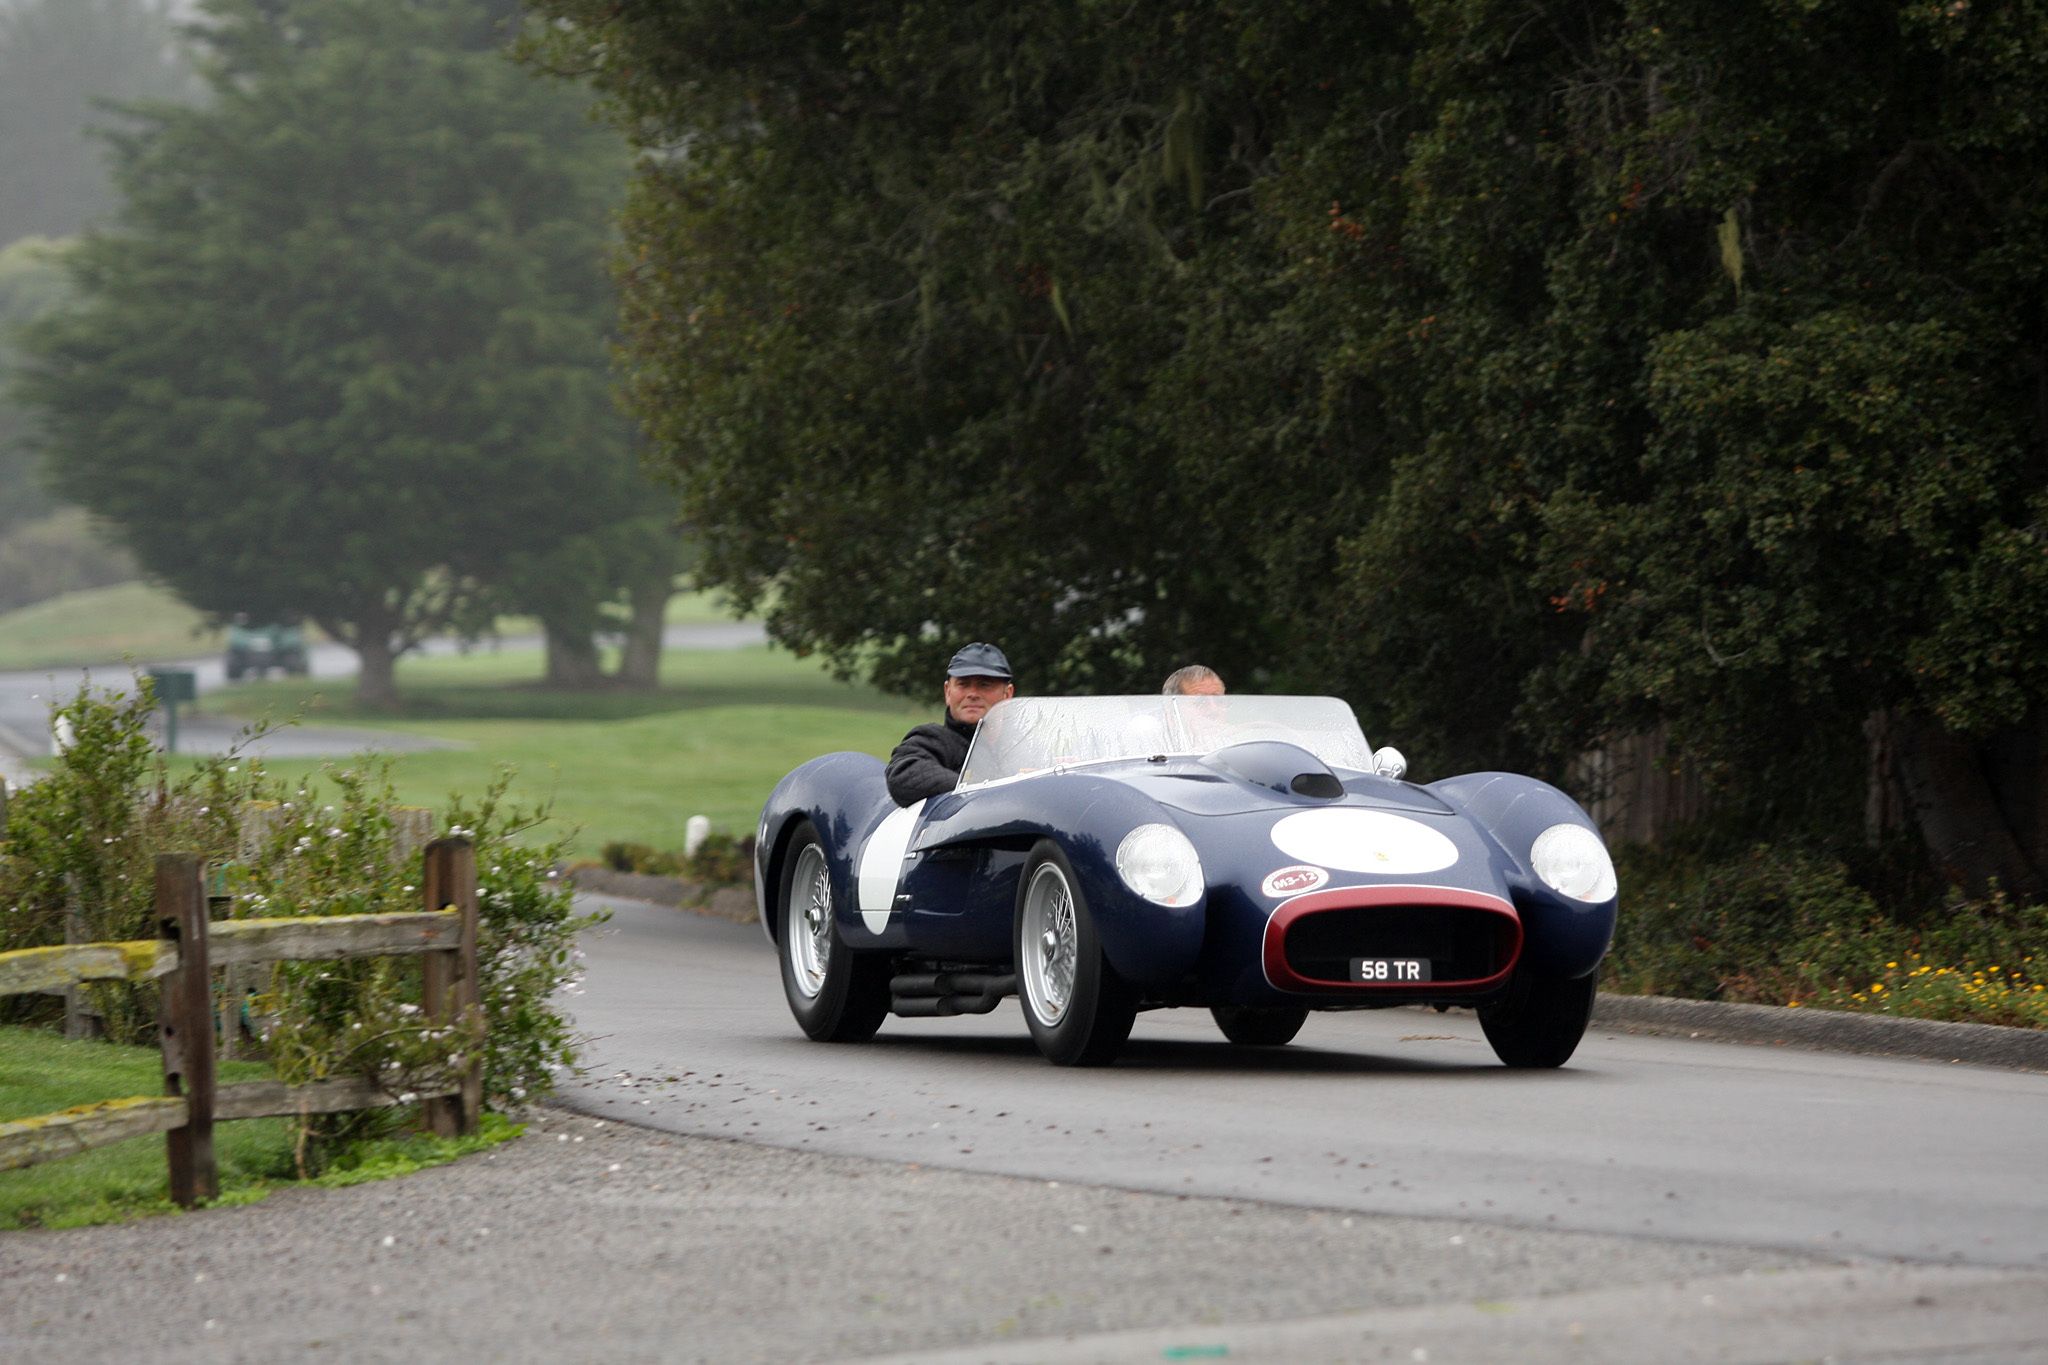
[535, 0, 2048, 894]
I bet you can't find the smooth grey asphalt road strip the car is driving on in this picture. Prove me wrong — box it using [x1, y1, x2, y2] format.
[567, 902, 2048, 1271]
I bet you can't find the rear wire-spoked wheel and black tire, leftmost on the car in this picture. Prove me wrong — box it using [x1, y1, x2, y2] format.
[774, 821, 889, 1044]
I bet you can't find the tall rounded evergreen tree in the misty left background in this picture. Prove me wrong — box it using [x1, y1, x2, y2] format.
[20, 0, 633, 704]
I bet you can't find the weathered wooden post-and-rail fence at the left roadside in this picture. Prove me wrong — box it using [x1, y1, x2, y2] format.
[0, 839, 483, 1207]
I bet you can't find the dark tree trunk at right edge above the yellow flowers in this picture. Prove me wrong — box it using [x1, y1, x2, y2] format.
[1890, 716, 2048, 898]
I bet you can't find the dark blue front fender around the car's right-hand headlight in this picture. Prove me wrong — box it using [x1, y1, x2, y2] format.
[1427, 774, 1620, 978]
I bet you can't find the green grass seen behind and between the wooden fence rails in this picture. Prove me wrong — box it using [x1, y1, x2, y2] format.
[0, 1027, 293, 1228]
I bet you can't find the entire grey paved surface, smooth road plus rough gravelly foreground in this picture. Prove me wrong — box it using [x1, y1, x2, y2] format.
[12, 902, 2048, 1365]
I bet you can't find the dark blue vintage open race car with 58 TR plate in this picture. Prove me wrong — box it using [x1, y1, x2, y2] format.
[754, 696, 1616, 1066]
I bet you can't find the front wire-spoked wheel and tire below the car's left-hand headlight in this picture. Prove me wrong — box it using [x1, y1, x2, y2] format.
[1012, 839, 1139, 1066]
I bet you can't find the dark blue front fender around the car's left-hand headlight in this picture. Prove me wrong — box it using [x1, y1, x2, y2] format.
[911, 772, 1206, 986]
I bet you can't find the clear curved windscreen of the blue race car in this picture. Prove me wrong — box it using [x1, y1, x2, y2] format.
[961, 694, 1372, 788]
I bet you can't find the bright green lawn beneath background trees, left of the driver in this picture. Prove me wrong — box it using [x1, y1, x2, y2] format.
[207, 647, 936, 855]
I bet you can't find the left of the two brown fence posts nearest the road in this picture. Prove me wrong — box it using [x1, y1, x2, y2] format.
[156, 853, 221, 1207]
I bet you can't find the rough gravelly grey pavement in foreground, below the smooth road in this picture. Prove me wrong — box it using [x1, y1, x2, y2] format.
[16, 1111, 2007, 1365]
